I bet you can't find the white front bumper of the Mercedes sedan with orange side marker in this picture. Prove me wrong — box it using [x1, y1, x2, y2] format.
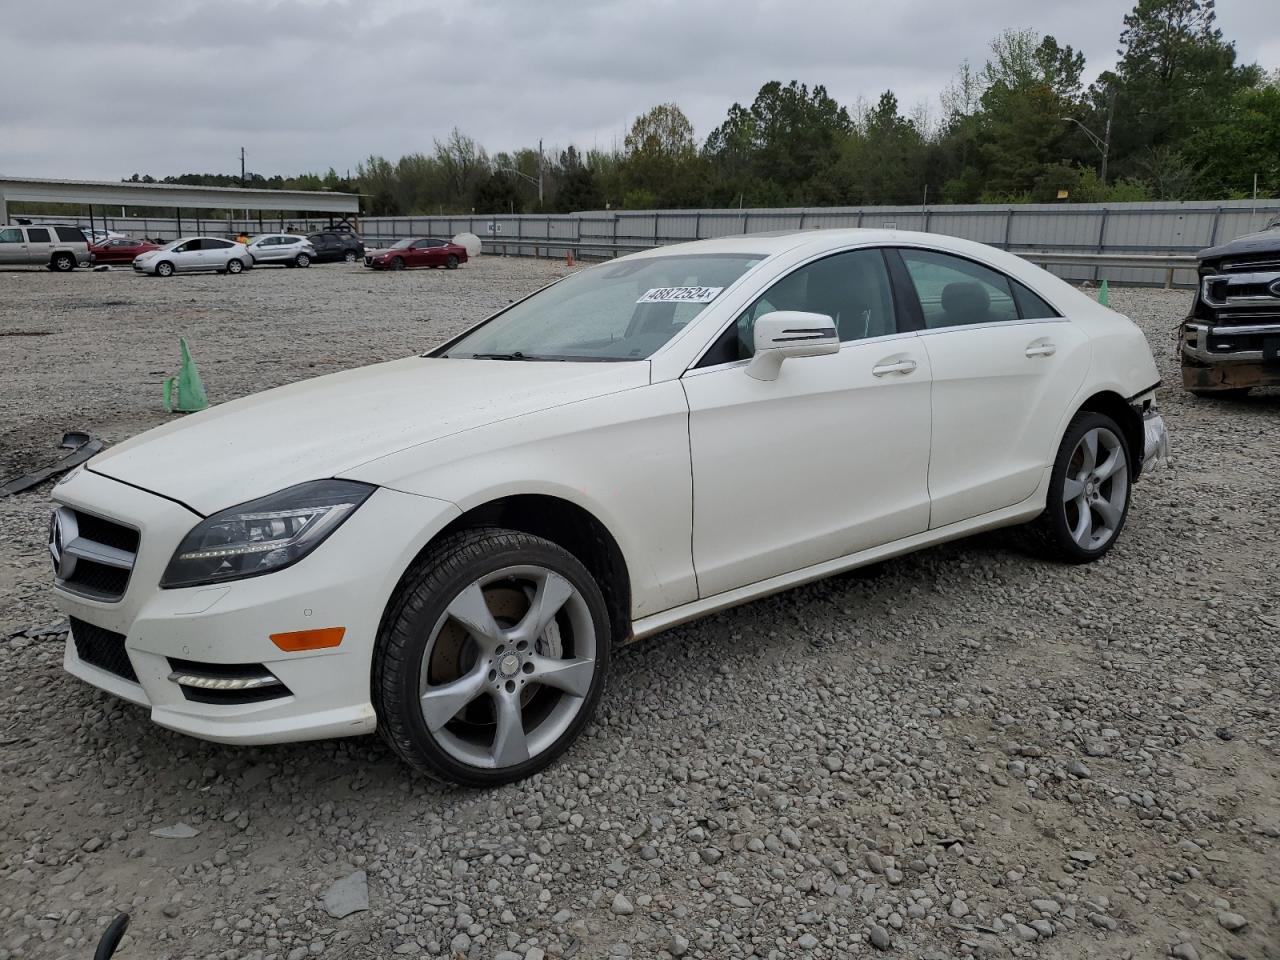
[54, 470, 458, 744]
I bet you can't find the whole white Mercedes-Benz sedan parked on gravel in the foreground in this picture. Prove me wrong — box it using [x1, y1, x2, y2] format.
[50, 230, 1167, 785]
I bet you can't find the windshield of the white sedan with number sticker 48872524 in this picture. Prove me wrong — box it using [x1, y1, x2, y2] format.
[444, 253, 764, 360]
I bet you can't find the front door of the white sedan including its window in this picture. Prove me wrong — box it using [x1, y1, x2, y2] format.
[682, 250, 929, 596]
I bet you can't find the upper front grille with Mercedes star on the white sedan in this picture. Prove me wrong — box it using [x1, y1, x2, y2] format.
[50, 507, 141, 603]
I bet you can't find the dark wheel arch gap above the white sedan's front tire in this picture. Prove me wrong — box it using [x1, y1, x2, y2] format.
[388, 493, 631, 644]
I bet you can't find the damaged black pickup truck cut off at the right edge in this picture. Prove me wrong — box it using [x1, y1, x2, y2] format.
[1178, 218, 1280, 397]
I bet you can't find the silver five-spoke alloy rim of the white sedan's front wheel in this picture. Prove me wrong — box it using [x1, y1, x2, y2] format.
[419, 566, 595, 769]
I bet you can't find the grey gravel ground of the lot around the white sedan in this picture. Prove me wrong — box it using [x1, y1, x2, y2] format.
[0, 259, 1280, 960]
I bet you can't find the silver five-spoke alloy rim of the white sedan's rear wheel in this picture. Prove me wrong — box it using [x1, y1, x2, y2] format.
[1062, 426, 1129, 550]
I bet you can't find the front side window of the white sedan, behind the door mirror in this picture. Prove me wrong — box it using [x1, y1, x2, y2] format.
[698, 250, 897, 366]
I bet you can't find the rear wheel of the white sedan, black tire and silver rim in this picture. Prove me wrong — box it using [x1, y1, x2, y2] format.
[1032, 411, 1132, 563]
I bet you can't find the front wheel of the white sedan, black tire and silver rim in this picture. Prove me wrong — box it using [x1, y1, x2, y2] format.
[372, 527, 611, 786]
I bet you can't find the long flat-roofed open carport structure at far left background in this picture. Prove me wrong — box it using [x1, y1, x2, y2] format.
[0, 175, 360, 234]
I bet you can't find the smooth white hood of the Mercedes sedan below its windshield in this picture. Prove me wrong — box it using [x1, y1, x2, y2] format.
[88, 357, 649, 516]
